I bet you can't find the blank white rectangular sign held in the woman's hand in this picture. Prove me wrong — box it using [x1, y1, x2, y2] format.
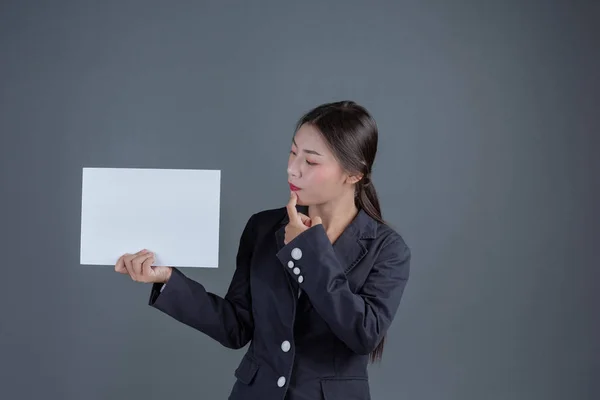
[80, 168, 221, 268]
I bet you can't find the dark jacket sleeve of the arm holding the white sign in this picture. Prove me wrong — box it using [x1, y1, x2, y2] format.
[149, 215, 254, 349]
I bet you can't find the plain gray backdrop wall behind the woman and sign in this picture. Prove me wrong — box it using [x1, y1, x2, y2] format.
[0, 0, 600, 400]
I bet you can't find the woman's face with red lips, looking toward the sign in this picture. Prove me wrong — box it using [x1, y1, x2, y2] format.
[287, 124, 356, 205]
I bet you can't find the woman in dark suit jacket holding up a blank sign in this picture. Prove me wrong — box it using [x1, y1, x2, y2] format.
[115, 101, 410, 400]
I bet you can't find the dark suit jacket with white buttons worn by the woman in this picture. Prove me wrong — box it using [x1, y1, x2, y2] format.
[149, 206, 410, 400]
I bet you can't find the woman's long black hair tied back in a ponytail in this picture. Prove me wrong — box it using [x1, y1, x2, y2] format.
[296, 100, 386, 362]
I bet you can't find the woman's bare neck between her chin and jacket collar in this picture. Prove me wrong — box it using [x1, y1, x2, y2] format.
[308, 194, 358, 242]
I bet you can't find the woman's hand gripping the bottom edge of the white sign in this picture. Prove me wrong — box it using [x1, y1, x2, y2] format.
[115, 249, 172, 283]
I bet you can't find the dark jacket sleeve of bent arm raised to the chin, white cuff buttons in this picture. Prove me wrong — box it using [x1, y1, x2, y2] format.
[277, 224, 411, 355]
